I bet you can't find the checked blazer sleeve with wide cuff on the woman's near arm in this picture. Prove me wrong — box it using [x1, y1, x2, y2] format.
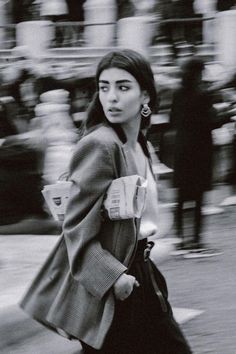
[63, 135, 127, 298]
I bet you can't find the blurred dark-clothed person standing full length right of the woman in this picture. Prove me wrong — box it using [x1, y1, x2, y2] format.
[170, 57, 230, 254]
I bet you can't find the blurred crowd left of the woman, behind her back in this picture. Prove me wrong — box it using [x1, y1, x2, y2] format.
[0, 48, 94, 225]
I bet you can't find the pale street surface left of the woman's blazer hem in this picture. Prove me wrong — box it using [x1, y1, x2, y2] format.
[0, 235, 81, 354]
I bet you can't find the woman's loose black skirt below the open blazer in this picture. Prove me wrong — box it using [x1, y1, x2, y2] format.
[82, 240, 192, 354]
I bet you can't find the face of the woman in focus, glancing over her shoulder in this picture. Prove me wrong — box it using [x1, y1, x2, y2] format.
[99, 68, 149, 124]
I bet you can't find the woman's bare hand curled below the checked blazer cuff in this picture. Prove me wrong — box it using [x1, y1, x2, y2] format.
[113, 273, 139, 301]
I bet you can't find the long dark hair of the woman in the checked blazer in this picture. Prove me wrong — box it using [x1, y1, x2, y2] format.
[85, 49, 157, 129]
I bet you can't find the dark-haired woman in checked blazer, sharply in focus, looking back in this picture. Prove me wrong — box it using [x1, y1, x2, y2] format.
[18, 50, 191, 354]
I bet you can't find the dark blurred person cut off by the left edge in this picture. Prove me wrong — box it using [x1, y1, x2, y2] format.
[0, 97, 47, 225]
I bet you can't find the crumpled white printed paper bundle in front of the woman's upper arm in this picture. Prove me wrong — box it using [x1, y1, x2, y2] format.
[104, 175, 147, 220]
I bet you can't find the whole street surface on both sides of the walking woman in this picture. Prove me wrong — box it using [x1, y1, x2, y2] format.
[0, 184, 236, 354]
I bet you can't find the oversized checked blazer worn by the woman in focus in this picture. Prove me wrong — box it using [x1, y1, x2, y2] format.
[20, 124, 150, 349]
